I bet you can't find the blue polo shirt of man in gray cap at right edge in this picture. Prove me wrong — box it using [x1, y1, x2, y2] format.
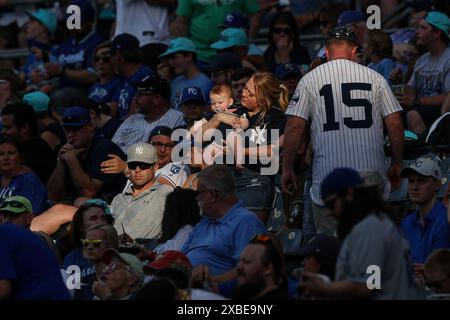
[402, 201, 450, 263]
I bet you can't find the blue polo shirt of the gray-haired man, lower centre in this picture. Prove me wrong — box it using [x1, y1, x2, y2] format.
[181, 201, 266, 275]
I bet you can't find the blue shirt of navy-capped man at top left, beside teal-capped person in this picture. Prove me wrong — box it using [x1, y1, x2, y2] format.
[56, 31, 104, 89]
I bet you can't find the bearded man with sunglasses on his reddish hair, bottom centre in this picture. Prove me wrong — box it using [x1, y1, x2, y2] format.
[233, 234, 289, 300]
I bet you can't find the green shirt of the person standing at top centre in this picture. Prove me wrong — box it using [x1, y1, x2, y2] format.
[177, 0, 260, 62]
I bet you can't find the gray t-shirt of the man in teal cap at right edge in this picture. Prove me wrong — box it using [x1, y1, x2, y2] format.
[408, 48, 450, 97]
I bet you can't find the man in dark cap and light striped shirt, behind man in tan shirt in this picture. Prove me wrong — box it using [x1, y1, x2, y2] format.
[112, 76, 185, 152]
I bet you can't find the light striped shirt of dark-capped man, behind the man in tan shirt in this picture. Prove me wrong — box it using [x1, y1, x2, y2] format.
[112, 109, 185, 153]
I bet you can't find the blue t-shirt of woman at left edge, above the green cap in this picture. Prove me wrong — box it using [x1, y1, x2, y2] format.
[0, 172, 47, 214]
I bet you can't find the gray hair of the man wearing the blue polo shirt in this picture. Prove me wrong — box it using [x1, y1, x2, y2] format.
[197, 164, 236, 197]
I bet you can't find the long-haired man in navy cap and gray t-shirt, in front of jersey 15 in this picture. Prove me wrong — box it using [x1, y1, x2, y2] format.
[299, 168, 416, 300]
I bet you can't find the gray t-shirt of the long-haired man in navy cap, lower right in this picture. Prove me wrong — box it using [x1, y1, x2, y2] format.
[336, 214, 417, 300]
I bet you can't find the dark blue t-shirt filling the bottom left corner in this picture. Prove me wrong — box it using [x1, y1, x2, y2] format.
[0, 223, 70, 300]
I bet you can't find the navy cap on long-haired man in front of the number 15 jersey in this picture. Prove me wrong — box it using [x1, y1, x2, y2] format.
[320, 168, 363, 199]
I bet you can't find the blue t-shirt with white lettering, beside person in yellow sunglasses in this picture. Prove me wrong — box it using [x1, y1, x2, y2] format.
[63, 247, 96, 300]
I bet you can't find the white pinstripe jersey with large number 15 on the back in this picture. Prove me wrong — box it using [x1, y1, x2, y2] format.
[286, 59, 402, 205]
